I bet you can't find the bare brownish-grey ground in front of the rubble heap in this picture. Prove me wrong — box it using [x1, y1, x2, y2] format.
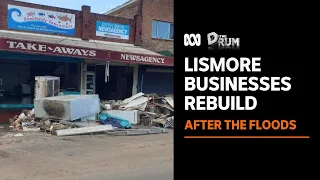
[0, 131, 173, 180]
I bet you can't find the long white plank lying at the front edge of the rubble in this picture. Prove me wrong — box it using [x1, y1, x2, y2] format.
[56, 125, 114, 136]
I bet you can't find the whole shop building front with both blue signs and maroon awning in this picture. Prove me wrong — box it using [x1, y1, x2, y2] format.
[0, 0, 173, 109]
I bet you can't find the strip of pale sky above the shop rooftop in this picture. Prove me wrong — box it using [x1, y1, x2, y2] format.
[17, 0, 128, 13]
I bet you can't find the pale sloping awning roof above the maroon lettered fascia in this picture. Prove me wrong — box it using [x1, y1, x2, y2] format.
[0, 30, 162, 56]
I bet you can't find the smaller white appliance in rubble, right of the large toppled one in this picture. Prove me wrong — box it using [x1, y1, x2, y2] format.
[105, 110, 140, 124]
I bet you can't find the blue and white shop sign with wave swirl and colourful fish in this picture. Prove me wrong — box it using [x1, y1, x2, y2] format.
[8, 4, 76, 36]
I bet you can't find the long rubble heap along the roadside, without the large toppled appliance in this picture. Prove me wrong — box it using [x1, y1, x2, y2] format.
[9, 93, 174, 136]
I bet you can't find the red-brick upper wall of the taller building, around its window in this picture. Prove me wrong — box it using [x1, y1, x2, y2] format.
[109, 0, 173, 52]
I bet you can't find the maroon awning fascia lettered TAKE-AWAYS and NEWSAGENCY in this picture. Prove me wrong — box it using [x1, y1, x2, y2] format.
[0, 39, 173, 66]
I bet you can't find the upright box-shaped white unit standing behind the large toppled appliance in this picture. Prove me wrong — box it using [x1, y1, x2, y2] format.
[34, 76, 60, 99]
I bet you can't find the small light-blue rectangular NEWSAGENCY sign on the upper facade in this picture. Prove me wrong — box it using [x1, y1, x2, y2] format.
[96, 21, 130, 40]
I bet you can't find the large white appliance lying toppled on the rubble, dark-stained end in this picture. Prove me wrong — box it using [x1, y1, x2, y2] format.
[34, 95, 100, 121]
